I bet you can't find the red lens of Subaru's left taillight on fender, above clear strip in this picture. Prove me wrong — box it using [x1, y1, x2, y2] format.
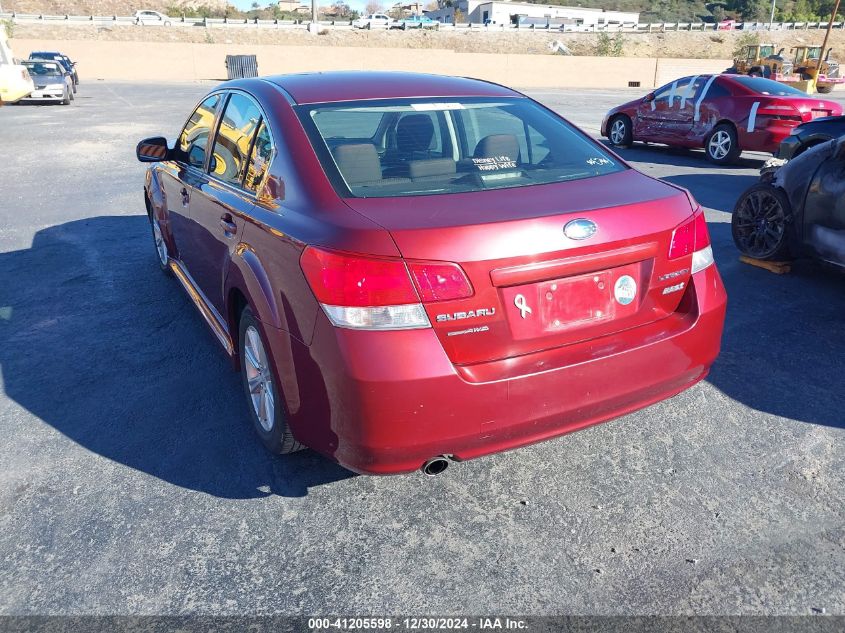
[300, 246, 420, 307]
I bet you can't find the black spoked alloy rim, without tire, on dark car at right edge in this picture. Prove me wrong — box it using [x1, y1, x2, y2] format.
[734, 190, 786, 259]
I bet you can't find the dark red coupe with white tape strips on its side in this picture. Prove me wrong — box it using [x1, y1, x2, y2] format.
[601, 75, 842, 164]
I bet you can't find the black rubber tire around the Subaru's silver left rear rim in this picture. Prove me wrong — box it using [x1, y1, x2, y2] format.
[238, 306, 305, 455]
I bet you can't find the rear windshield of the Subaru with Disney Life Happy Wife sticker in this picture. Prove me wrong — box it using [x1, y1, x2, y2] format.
[297, 98, 625, 198]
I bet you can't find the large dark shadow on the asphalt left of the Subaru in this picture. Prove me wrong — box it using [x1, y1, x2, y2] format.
[0, 216, 353, 498]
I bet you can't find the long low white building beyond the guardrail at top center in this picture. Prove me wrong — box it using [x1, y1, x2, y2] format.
[426, 0, 640, 26]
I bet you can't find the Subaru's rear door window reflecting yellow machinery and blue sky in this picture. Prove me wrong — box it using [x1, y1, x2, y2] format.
[209, 92, 261, 186]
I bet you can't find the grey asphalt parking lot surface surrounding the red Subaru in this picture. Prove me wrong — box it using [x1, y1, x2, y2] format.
[0, 76, 845, 616]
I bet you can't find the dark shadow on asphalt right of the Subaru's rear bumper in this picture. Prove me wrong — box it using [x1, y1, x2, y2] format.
[707, 222, 845, 432]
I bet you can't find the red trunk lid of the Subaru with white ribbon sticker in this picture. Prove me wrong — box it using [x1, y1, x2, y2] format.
[340, 170, 692, 364]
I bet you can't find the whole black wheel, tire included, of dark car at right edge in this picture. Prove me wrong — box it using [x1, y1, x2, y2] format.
[731, 183, 792, 260]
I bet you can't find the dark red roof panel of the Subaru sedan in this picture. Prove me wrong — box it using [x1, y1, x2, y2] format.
[263, 71, 522, 104]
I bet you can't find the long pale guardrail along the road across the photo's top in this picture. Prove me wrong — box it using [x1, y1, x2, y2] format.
[0, 12, 845, 33]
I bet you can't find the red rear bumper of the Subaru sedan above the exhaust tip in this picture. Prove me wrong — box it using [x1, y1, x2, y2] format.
[278, 266, 726, 474]
